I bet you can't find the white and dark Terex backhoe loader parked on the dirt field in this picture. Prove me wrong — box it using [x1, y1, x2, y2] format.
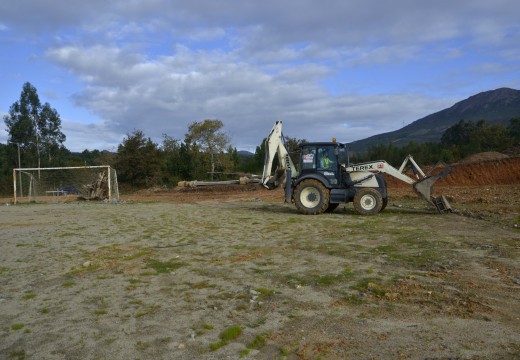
[261, 121, 451, 215]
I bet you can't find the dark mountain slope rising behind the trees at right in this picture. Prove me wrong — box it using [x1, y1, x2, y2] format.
[348, 88, 520, 152]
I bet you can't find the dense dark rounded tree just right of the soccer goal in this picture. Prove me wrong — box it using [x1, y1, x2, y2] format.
[115, 130, 162, 188]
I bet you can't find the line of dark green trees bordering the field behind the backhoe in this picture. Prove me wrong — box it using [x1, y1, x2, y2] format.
[0, 82, 520, 195]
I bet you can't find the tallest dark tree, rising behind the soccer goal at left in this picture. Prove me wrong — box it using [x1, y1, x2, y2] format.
[4, 82, 65, 167]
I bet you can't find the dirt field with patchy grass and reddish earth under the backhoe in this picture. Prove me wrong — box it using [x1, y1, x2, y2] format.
[0, 158, 520, 359]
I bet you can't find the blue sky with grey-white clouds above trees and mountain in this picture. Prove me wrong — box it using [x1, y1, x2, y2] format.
[0, 0, 520, 152]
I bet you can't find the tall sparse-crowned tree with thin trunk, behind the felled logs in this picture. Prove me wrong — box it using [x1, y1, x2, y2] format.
[185, 119, 229, 179]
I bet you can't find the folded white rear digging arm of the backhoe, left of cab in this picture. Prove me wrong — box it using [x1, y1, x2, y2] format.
[262, 121, 298, 190]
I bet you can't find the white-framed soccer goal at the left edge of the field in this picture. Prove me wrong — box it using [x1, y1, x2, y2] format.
[13, 165, 119, 204]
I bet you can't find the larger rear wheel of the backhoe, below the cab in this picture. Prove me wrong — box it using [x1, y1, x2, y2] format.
[294, 179, 330, 215]
